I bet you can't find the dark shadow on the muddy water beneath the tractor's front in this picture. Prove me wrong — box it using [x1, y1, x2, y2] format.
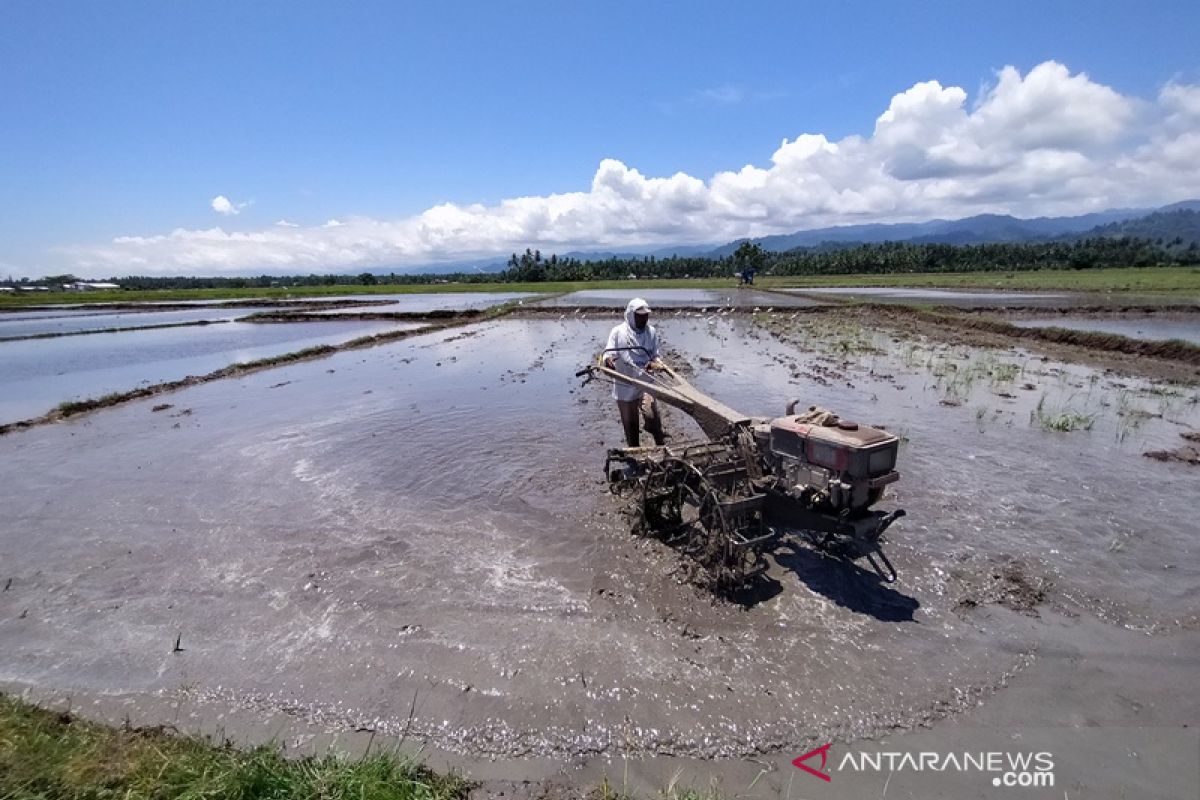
[774, 540, 920, 622]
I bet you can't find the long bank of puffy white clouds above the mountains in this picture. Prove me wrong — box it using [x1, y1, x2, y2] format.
[70, 61, 1200, 275]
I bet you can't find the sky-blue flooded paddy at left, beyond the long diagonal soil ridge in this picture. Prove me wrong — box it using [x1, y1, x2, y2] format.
[0, 319, 419, 422]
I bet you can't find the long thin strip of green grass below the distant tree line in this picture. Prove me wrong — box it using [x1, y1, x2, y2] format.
[9, 266, 1200, 308]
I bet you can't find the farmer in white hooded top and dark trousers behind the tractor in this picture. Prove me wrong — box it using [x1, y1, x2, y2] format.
[604, 297, 664, 447]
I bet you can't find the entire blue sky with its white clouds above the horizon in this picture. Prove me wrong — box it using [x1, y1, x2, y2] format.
[0, 0, 1200, 275]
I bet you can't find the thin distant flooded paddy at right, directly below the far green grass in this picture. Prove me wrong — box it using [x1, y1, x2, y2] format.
[784, 287, 1198, 308]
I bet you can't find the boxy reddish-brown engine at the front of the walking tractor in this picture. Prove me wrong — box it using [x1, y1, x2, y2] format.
[755, 409, 900, 518]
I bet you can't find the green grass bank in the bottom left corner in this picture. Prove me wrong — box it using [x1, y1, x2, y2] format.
[0, 694, 470, 800]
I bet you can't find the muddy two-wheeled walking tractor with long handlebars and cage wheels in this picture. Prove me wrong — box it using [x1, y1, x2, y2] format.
[577, 352, 905, 593]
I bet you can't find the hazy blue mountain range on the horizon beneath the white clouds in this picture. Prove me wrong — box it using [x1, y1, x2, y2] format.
[371, 199, 1200, 275]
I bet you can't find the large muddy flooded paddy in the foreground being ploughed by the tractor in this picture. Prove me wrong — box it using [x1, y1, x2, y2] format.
[0, 300, 1200, 796]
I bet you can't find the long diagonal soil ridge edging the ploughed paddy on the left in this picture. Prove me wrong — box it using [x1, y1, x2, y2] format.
[0, 317, 458, 435]
